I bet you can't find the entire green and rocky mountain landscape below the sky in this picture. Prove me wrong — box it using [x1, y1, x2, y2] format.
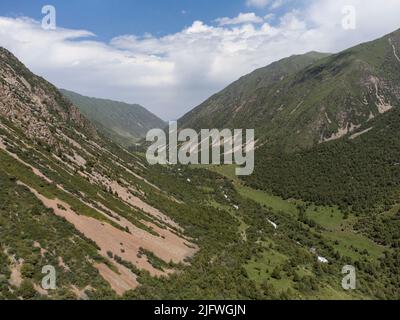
[0, 31, 400, 299]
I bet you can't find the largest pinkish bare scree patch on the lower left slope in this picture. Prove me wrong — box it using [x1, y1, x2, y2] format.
[18, 182, 197, 292]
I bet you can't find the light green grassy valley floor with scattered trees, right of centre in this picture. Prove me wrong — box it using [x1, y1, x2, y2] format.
[192, 165, 399, 299]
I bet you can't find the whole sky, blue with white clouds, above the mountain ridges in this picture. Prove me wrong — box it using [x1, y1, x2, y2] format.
[0, 0, 400, 120]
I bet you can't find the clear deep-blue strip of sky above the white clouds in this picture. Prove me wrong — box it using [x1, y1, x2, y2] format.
[0, 0, 301, 41]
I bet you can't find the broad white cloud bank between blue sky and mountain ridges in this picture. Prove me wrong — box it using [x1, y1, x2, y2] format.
[0, 0, 400, 120]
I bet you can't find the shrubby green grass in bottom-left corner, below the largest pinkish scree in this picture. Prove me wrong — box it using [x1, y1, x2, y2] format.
[0, 169, 115, 300]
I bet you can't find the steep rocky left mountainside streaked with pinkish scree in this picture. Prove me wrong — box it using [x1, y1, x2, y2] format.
[0, 49, 198, 297]
